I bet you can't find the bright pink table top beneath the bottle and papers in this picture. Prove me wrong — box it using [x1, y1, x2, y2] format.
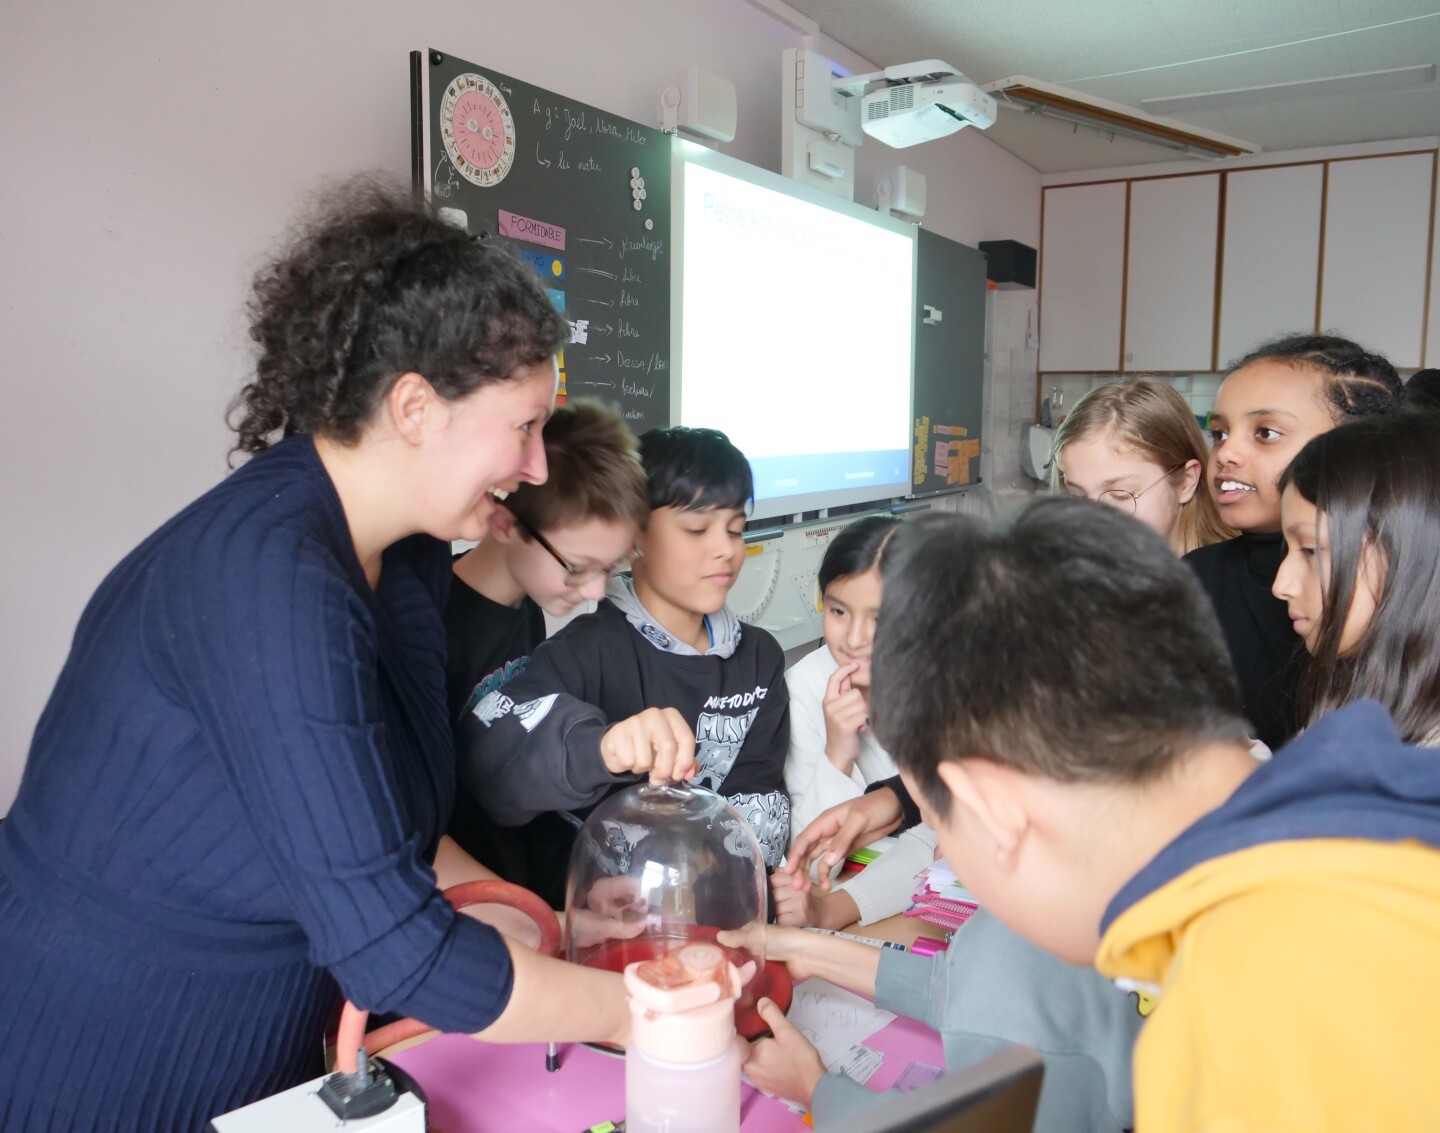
[392, 996, 945, 1133]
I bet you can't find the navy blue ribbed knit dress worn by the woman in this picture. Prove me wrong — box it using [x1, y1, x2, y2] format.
[0, 438, 513, 1133]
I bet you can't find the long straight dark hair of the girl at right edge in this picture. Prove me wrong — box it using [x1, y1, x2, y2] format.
[1280, 413, 1440, 744]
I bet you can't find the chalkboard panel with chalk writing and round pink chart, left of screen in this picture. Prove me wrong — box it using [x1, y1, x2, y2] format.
[410, 50, 670, 433]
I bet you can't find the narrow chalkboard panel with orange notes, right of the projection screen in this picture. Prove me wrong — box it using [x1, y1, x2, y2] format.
[910, 229, 985, 495]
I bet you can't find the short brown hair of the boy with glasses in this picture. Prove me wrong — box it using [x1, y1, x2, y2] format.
[505, 399, 649, 533]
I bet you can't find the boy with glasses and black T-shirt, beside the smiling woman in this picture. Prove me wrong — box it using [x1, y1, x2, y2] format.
[445, 400, 649, 888]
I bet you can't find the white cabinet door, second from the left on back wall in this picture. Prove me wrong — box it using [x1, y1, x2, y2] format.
[1125, 173, 1220, 370]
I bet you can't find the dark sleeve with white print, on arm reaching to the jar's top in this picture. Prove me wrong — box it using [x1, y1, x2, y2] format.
[455, 638, 625, 826]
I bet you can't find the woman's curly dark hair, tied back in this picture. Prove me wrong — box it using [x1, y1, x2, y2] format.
[229, 179, 569, 452]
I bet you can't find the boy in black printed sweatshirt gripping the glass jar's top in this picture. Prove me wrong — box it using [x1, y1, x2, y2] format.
[459, 428, 789, 898]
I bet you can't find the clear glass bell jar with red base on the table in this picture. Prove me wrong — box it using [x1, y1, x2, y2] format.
[564, 783, 791, 1038]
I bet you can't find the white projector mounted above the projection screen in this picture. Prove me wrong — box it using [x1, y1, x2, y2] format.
[835, 59, 995, 150]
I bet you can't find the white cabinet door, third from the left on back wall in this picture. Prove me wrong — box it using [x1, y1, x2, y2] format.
[1217, 163, 1325, 369]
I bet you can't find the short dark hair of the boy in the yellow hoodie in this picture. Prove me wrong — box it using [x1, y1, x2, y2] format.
[871, 498, 1247, 818]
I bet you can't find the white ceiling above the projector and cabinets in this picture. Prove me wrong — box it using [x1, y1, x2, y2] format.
[788, 0, 1440, 173]
